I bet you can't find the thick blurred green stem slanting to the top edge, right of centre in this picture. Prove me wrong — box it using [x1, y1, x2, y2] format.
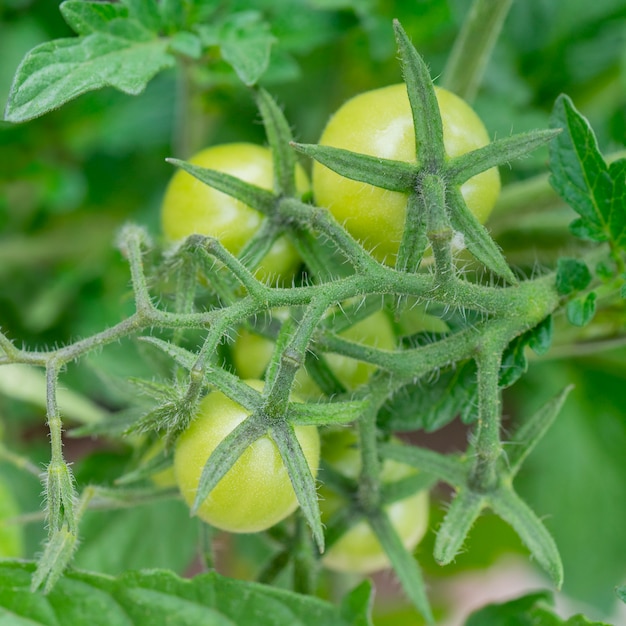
[441, 0, 513, 101]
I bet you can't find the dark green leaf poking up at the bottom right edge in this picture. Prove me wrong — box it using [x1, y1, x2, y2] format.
[465, 591, 609, 626]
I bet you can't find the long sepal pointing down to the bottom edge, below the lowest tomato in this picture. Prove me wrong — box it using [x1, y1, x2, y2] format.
[367, 510, 434, 624]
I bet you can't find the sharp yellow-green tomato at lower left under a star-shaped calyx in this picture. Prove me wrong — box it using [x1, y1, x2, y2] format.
[174, 380, 320, 533]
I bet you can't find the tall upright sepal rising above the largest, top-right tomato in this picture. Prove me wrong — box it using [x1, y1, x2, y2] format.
[393, 20, 446, 173]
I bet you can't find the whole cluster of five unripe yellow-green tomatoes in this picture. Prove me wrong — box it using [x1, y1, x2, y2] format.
[162, 85, 500, 572]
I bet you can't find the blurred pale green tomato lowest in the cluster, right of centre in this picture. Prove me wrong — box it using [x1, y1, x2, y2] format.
[320, 430, 429, 574]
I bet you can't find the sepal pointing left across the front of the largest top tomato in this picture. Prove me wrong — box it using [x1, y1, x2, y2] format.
[291, 143, 418, 193]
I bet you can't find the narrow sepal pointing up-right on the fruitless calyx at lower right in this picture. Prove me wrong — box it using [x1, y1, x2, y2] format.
[504, 385, 573, 477]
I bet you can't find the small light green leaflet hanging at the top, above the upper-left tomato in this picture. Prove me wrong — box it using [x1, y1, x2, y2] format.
[220, 11, 275, 87]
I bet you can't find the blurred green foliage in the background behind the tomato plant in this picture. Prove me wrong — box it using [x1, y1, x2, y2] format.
[0, 0, 626, 624]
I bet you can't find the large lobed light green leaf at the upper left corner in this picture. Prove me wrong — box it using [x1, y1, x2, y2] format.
[5, 29, 175, 122]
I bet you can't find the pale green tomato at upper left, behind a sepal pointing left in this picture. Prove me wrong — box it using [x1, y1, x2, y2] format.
[161, 143, 309, 280]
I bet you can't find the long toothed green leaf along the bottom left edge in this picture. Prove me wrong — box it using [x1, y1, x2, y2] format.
[0, 562, 367, 626]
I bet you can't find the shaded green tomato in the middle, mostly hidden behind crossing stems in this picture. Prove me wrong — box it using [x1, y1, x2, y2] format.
[233, 311, 396, 398]
